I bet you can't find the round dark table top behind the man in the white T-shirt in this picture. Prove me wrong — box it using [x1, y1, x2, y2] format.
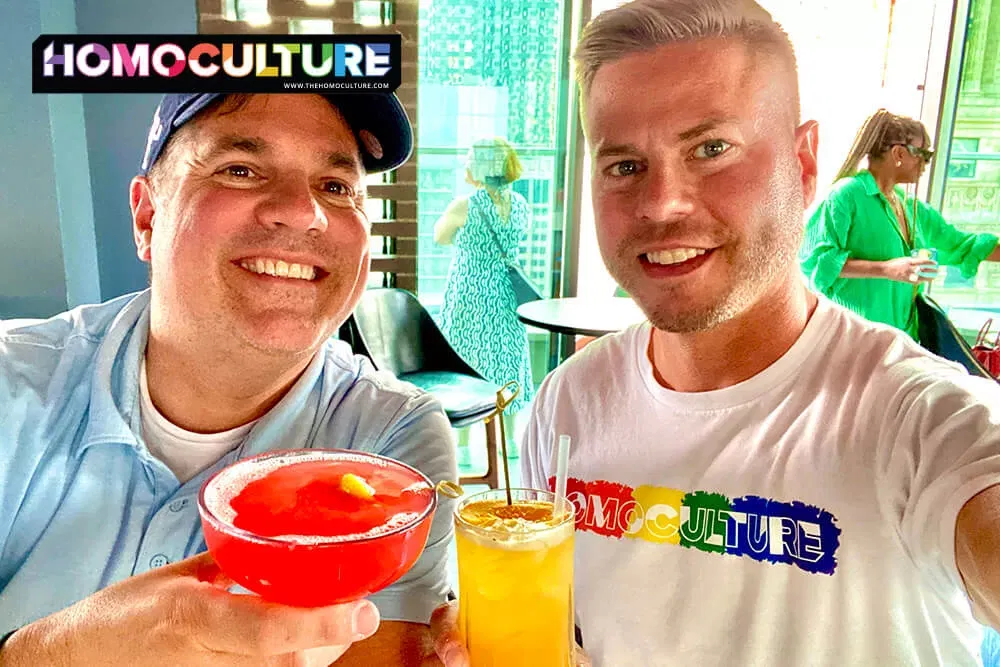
[517, 297, 646, 336]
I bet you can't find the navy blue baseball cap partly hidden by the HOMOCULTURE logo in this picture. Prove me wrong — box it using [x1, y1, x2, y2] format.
[139, 93, 413, 175]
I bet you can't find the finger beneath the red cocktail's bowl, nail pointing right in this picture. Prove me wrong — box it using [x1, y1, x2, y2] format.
[204, 595, 379, 664]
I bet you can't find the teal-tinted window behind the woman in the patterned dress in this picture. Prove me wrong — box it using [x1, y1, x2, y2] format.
[416, 0, 569, 380]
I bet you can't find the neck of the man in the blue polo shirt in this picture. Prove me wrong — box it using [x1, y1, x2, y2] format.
[146, 327, 311, 433]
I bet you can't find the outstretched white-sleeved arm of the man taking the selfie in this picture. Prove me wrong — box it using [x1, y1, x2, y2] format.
[876, 368, 1000, 628]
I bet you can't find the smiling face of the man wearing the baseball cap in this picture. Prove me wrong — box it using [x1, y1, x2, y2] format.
[132, 95, 369, 356]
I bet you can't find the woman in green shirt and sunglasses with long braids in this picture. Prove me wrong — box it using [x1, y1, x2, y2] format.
[801, 109, 1000, 339]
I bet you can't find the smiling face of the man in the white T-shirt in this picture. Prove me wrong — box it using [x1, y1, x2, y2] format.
[584, 38, 816, 333]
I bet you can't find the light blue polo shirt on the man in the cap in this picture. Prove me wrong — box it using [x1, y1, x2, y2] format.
[0, 291, 457, 634]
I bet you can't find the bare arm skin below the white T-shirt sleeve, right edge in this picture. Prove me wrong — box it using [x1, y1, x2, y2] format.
[955, 485, 1000, 630]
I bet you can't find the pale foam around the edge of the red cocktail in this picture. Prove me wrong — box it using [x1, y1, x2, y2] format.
[205, 449, 433, 545]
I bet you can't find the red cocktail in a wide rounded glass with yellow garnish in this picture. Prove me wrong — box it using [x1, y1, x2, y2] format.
[198, 449, 437, 607]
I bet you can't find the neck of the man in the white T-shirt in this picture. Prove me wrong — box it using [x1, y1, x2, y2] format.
[650, 274, 818, 392]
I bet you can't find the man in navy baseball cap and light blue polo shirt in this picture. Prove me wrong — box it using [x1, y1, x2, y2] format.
[0, 94, 456, 666]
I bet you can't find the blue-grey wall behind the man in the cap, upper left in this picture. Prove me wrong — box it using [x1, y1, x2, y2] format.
[0, 0, 197, 318]
